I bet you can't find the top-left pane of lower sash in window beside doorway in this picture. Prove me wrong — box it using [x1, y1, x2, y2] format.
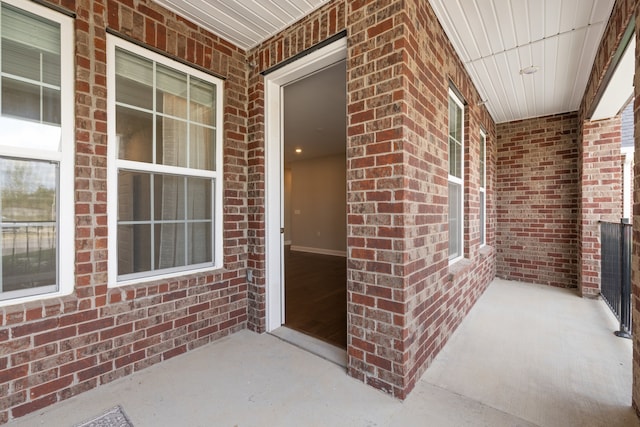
[118, 171, 151, 221]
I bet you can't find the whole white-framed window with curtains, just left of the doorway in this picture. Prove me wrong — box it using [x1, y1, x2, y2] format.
[108, 36, 222, 286]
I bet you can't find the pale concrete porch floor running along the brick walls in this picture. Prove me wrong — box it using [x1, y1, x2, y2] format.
[9, 279, 640, 427]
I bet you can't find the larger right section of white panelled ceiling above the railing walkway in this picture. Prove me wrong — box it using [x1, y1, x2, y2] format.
[429, 0, 615, 123]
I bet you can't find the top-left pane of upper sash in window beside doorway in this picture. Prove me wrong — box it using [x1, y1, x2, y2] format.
[116, 49, 153, 110]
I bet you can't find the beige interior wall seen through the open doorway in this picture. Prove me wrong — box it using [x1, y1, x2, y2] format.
[292, 154, 347, 256]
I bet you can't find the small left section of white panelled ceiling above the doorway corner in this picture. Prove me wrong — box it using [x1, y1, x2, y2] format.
[154, 0, 329, 50]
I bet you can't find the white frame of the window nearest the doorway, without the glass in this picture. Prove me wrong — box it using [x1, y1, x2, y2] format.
[107, 34, 224, 287]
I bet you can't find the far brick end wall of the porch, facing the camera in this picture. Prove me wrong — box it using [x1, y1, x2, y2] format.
[496, 113, 579, 287]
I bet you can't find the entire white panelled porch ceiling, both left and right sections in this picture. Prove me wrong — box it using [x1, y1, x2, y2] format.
[155, 0, 615, 123]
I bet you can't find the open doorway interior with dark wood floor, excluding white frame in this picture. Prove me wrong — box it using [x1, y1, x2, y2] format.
[283, 60, 347, 348]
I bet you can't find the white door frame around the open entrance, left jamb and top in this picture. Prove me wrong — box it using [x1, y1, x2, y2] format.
[264, 38, 347, 332]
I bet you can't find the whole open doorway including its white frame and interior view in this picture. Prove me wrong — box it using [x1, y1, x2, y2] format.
[265, 39, 347, 349]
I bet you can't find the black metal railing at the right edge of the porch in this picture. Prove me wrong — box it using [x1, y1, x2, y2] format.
[600, 221, 632, 338]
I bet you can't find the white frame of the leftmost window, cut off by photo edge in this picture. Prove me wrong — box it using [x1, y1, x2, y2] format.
[0, 0, 75, 307]
